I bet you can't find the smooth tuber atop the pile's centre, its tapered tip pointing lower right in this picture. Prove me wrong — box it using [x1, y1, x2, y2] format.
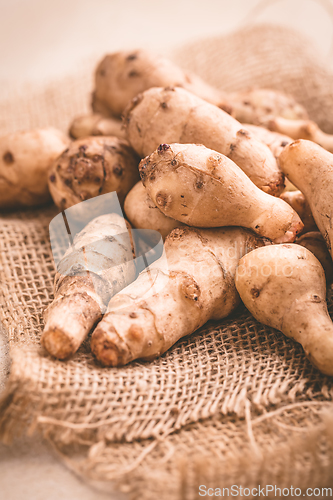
[139, 144, 303, 242]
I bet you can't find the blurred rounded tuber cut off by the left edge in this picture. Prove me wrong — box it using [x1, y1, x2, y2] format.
[0, 128, 69, 209]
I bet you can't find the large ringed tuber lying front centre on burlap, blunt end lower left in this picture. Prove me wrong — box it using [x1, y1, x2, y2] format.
[91, 227, 264, 366]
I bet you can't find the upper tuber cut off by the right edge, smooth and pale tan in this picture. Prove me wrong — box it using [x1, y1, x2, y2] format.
[280, 140, 333, 256]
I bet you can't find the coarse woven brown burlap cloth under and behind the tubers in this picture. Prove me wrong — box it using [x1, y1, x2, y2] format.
[0, 26, 333, 500]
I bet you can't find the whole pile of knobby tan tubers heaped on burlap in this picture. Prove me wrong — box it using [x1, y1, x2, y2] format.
[0, 50, 333, 375]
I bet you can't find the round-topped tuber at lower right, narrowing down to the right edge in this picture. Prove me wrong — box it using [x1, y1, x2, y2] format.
[235, 245, 333, 375]
